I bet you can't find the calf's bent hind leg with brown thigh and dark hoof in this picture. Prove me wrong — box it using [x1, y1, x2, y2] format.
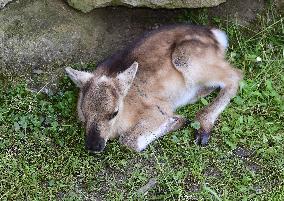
[172, 41, 242, 145]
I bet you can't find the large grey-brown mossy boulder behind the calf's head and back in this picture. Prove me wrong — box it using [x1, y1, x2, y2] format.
[0, 0, 181, 88]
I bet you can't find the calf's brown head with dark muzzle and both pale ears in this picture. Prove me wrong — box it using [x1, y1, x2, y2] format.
[65, 62, 138, 152]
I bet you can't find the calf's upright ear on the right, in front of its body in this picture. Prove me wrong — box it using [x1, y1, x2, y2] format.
[116, 62, 138, 95]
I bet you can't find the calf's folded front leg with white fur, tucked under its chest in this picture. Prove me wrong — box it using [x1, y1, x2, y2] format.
[120, 116, 188, 152]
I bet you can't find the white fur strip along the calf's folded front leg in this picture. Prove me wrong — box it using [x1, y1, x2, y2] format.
[137, 118, 175, 151]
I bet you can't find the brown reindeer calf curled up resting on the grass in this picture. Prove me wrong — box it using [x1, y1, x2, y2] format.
[65, 25, 242, 152]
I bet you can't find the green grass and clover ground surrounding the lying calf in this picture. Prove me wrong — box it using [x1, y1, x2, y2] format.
[0, 3, 284, 200]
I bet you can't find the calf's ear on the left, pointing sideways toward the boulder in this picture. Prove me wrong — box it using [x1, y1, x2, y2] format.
[65, 67, 94, 88]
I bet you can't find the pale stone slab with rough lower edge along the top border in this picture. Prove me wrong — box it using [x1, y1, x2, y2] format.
[67, 0, 226, 13]
